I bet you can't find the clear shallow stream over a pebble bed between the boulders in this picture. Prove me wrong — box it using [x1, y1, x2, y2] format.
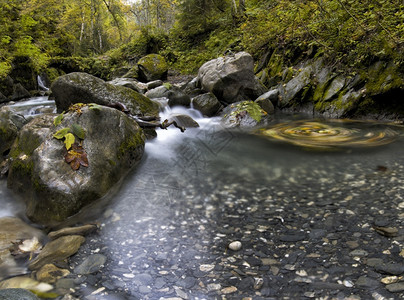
[0, 99, 404, 300]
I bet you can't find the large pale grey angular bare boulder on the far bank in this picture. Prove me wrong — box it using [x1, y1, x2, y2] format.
[198, 52, 267, 104]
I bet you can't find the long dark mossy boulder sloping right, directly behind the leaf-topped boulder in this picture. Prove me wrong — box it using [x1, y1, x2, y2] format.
[51, 72, 158, 117]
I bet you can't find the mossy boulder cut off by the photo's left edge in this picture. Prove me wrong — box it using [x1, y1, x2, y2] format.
[0, 106, 26, 163]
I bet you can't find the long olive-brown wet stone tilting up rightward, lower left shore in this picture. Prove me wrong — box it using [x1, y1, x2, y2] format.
[28, 235, 85, 270]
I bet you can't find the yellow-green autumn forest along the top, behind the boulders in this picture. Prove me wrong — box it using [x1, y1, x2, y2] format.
[0, 0, 404, 80]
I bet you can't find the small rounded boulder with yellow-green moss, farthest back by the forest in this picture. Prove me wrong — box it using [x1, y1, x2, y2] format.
[137, 54, 168, 82]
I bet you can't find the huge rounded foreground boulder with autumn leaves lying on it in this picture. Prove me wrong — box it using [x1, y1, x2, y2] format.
[7, 105, 145, 225]
